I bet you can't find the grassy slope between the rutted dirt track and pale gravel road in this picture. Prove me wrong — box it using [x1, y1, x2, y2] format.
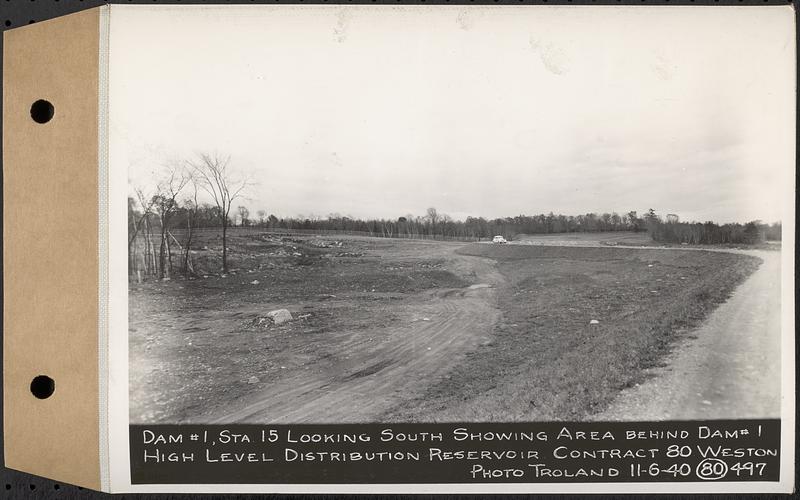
[387, 245, 759, 421]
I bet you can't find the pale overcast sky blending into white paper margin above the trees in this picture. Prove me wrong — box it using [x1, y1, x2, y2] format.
[109, 5, 795, 222]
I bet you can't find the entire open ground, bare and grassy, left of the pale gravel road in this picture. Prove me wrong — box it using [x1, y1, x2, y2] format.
[130, 230, 760, 423]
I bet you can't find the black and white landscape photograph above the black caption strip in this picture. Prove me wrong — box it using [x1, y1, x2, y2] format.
[117, 5, 795, 425]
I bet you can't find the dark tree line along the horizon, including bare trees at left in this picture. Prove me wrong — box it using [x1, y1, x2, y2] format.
[128, 160, 781, 280]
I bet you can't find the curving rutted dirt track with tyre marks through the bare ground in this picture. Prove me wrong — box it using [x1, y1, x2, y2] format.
[206, 256, 502, 423]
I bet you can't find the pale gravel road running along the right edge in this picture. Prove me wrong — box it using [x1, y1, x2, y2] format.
[594, 251, 781, 420]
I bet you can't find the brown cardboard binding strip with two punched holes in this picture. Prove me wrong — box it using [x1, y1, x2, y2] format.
[3, 5, 100, 489]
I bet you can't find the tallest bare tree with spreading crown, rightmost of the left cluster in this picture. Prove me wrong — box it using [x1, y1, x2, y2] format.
[188, 154, 249, 273]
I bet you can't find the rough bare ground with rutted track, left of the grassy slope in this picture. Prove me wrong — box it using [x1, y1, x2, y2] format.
[129, 236, 494, 422]
